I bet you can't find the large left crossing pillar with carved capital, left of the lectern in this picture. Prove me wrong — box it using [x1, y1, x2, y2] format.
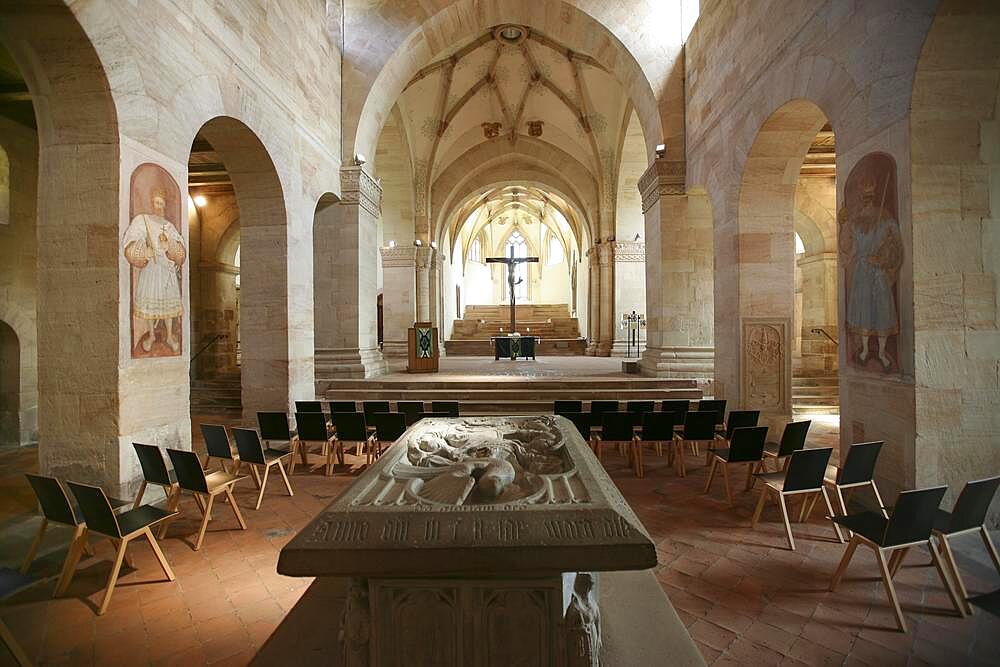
[314, 167, 387, 394]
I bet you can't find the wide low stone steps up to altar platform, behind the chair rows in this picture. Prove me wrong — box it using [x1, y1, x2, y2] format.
[324, 377, 702, 415]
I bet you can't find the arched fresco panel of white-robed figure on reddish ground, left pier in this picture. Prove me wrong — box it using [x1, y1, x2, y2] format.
[122, 162, 187, 359]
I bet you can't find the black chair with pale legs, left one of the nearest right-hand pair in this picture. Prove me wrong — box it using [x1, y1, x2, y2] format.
[830, 486, 965, 632]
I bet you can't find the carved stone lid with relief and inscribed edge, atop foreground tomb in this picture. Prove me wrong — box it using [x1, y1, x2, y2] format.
[278, 415, 656, 577]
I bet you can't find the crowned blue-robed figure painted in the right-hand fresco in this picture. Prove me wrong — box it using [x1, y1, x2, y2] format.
[837, 168, 903, 370]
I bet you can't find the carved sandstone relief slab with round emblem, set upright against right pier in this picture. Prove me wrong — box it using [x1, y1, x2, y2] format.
[740, 317, 791, 411]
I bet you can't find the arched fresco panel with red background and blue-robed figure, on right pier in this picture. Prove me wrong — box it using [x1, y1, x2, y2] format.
[837, 153, 903, 375]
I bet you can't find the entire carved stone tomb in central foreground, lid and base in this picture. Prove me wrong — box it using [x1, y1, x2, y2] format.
[278, 416, 656, 665]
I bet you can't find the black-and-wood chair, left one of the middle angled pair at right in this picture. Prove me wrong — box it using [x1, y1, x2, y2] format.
[750, 447, 844, 551]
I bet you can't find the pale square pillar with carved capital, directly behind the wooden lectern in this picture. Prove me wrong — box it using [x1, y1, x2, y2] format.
[379, 246, 417, 366]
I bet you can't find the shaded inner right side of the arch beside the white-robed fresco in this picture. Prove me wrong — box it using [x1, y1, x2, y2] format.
[198, 116, 294, 422]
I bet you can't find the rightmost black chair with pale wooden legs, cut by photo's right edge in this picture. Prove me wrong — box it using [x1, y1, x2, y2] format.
[928, 476, 1000, 614]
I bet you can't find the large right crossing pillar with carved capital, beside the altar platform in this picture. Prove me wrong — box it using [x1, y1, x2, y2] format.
[639, 158, 715, 380]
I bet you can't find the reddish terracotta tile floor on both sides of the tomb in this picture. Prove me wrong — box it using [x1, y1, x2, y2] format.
[0, 422, 1000, 667]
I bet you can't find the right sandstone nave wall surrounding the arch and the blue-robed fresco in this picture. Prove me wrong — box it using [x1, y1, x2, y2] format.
[685, 0, 936, 495]
